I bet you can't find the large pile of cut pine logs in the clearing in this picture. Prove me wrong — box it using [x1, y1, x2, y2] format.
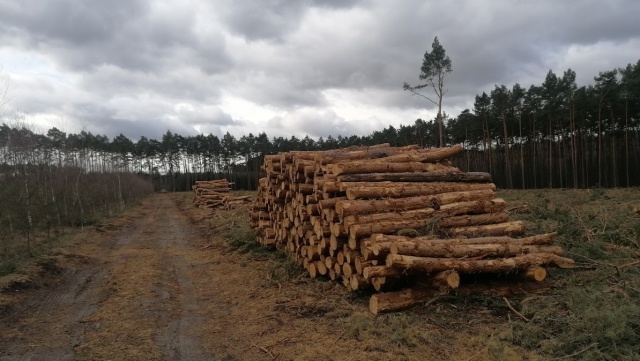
[250, 144, 574, 313]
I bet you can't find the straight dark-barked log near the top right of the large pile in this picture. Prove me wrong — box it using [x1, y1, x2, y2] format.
[338, 172, 491, 183]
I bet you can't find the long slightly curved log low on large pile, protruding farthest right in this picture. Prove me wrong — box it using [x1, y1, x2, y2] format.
[386, 253, 575, 273]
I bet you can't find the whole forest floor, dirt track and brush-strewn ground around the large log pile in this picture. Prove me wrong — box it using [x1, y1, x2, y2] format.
[0, 190, 640, 361]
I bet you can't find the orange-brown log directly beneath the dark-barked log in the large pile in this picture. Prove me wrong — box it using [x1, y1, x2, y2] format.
[346, 182, 496, 200]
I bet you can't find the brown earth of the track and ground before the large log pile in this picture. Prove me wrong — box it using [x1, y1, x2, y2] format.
[0, 194, 540, 361]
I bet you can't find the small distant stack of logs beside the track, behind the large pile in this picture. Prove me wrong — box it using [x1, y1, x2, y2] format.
[191, 179, 251, 209]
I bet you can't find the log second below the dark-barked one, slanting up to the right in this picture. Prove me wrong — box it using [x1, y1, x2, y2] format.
[336, 189, 496, 218]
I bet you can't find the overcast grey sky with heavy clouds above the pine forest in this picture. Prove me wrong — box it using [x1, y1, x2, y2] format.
[0, 0, 640, 140]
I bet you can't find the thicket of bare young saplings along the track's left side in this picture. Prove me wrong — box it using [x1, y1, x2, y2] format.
[0, 124, 153, 256]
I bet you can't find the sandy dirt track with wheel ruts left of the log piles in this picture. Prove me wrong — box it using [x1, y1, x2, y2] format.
[0, 195, 215, 361]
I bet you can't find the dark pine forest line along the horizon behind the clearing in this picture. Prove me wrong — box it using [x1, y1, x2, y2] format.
[0, 60, 640, 197]
